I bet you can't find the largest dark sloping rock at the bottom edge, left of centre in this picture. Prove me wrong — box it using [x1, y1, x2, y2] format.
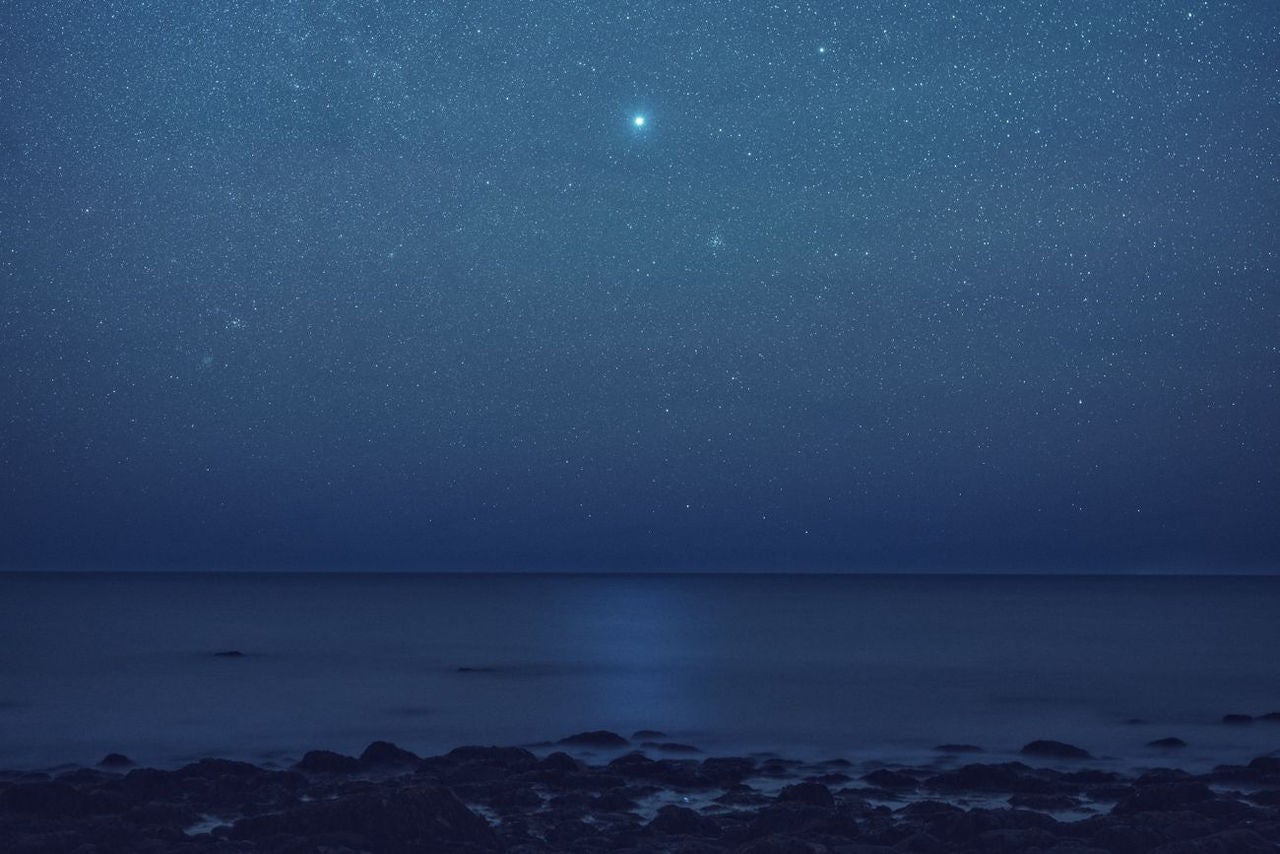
[230, 786, 499, 854]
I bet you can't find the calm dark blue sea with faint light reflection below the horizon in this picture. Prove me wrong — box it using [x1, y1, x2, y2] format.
[0, 574, 1280, 768]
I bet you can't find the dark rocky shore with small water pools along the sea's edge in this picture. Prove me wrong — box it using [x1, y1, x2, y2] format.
[0, 731, 1280, 854]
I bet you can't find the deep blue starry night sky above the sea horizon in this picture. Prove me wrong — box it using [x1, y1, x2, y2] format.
[0, 0, 1280, 571]
